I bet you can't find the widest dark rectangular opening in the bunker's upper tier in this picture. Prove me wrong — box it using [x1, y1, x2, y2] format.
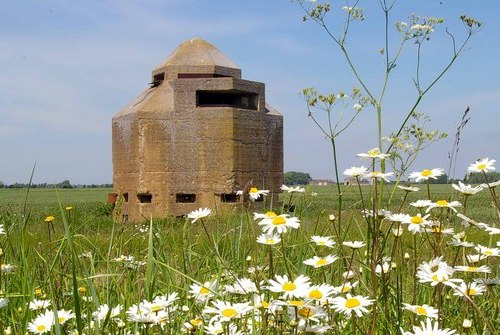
[196, 91, 259, 110]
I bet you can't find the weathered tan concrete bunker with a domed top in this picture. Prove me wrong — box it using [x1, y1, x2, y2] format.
[113, 39, 283, 221]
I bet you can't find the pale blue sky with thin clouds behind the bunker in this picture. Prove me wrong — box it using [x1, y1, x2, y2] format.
[0, 0, 500, 183]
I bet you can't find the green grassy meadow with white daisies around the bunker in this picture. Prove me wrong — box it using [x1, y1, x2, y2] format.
[0, 185, 500, 335]
